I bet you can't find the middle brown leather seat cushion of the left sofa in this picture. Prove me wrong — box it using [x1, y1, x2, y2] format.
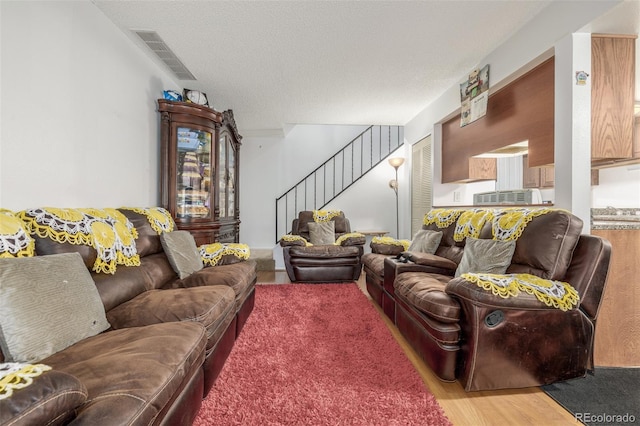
[107, 285, 235, 349]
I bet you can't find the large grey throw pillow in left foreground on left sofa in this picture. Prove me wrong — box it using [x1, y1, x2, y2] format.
[0, 253, 110, 363]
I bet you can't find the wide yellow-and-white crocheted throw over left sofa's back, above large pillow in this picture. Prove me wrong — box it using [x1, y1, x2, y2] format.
[19, 207, 140, 274]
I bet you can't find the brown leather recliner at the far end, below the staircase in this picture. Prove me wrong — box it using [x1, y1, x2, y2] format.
[280, 210, 365, 283]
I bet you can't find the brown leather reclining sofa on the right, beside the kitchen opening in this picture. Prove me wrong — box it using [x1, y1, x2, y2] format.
[363, 210, 611, 391]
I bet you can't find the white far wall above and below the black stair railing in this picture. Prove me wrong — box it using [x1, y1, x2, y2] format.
[240, 125, 407, 248]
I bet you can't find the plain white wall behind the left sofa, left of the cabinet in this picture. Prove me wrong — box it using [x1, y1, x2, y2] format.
[0, 1, 180, 210]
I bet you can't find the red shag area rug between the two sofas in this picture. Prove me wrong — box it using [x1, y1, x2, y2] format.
[194, 283, 451, 426]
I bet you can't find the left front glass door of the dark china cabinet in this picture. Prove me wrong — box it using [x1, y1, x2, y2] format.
[175, 127, 214, 219]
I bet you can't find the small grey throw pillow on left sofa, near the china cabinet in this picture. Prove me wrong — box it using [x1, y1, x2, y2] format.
[160, 231, 204, 279]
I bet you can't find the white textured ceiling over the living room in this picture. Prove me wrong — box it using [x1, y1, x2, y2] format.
[93, 0, 640, 135]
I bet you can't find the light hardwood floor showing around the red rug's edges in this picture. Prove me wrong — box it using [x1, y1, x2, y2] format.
[258, 271, 581, 426]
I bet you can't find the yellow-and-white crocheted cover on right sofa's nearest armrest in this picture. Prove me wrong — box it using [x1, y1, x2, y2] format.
[461, 274, 580, 311]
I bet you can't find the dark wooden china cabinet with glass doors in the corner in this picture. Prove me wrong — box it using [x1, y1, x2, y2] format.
[158, 99, 242, 245]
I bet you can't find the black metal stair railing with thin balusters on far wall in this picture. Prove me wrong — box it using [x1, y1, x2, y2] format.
[275, 126, 404, 242]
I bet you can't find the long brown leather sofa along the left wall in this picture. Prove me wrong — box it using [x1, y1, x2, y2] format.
[0, 209, 256, 425]
